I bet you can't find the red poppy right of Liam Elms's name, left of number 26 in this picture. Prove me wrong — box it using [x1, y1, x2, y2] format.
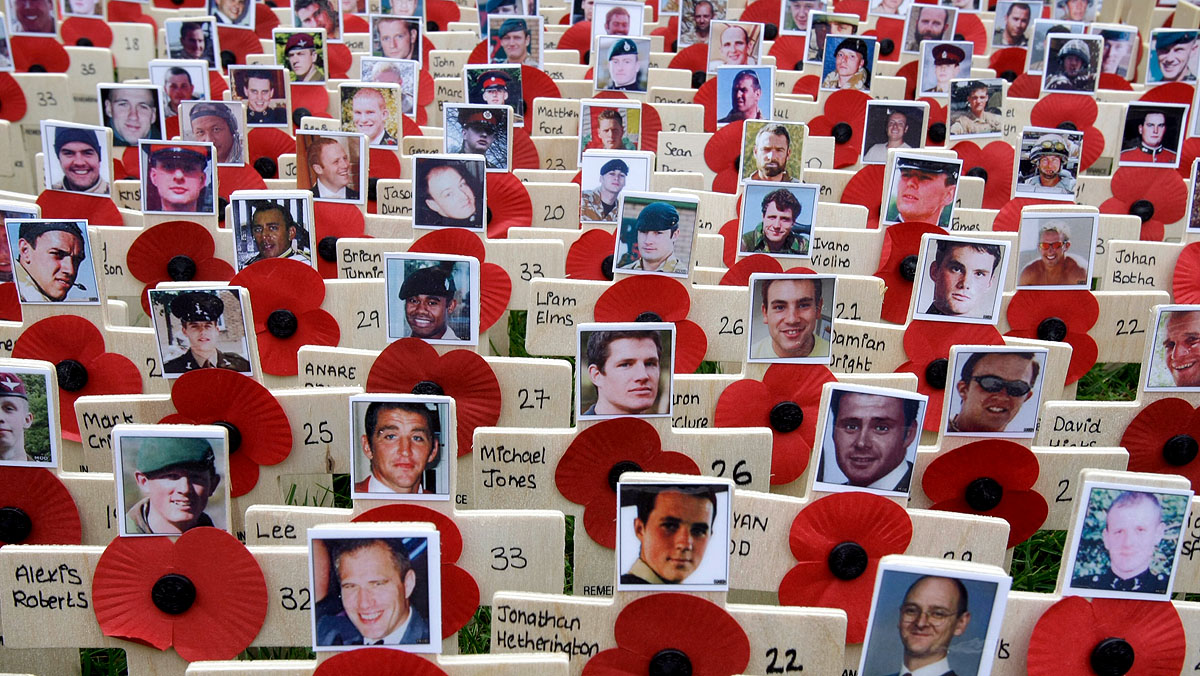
[593, 275, 708, 373]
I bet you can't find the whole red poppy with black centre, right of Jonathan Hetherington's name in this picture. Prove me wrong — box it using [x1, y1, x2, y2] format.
[583, 593, 750, 676]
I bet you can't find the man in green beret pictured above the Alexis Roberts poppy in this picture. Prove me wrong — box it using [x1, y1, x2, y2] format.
[125, 437, 221, 536]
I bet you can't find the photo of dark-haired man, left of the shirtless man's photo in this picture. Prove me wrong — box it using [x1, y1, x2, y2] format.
[916, 238, 1006, 323]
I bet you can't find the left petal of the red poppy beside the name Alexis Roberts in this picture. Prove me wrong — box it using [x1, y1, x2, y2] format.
[91, 538, 175, 650]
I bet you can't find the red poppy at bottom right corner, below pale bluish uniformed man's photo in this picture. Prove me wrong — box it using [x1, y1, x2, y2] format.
[1025, 597, 1187, 676]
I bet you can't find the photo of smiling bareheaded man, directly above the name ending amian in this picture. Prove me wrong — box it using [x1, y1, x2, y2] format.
[748, 274, 834, 364]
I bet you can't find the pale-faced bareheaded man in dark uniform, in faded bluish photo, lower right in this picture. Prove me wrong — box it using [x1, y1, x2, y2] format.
[1072, 491, 1170, 594]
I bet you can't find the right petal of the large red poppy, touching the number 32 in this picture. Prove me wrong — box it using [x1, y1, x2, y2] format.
[171, 528, 268, 662]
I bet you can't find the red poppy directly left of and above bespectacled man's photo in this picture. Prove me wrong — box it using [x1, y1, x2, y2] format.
[779, 491, 912, 644]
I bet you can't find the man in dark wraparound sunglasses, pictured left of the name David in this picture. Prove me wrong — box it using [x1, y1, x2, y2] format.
[946, 352, 1040, 432]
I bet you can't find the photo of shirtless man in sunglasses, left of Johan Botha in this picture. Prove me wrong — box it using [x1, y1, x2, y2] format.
[1016, 213, 1098, 288]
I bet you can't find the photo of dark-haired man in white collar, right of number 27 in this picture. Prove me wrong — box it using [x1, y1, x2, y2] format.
[577, 324, 674, 417]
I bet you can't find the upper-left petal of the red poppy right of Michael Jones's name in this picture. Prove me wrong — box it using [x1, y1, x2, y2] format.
[554, 417, 662, 509]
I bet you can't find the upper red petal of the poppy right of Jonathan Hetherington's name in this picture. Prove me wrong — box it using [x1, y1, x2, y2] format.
[613, 593, 750, 675]
